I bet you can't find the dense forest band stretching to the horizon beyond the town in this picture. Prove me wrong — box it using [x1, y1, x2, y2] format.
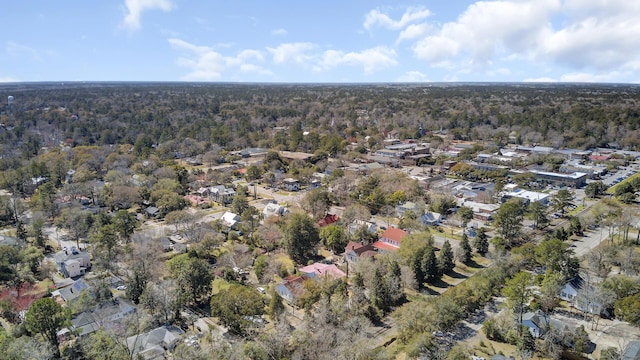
[0, 83, 640, 160]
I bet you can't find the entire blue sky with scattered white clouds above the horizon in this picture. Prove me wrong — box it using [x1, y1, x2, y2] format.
[0, 0, 640, 83]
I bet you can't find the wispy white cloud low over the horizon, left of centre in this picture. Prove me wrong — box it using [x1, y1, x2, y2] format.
[168, 38, 273, 81]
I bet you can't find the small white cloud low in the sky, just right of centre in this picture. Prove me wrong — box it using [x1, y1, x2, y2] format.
[316, 46, 398, 73]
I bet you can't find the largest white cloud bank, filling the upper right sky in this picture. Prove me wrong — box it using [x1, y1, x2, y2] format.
[402, 0, 640, 81]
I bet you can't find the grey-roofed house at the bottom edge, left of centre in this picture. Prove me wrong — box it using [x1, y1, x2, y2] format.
[127, 326, 184, 359]
